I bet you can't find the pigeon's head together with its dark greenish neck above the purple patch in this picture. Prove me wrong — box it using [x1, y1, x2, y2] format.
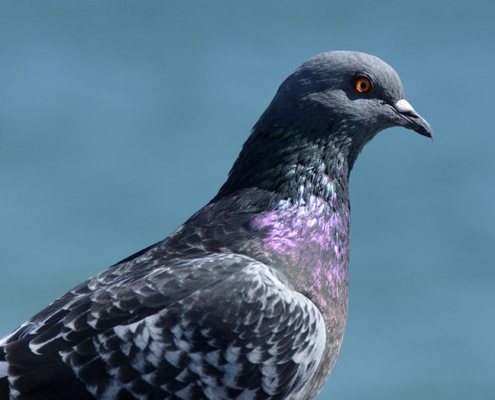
[219, 51, 432, 202]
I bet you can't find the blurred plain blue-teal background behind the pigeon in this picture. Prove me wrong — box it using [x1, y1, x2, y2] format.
[0, 0, 495, 400]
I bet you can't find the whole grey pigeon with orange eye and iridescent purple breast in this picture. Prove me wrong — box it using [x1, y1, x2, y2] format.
[0, 51, 432, 400]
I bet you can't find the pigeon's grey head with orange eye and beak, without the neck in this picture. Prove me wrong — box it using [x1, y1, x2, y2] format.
[272, 51, 432, 142]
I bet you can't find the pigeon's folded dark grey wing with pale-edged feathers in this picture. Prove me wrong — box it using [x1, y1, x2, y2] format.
[4, 254, 326, 400]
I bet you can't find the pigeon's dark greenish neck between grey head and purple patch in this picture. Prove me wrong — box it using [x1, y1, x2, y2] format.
[214, 127, 354, 205]
